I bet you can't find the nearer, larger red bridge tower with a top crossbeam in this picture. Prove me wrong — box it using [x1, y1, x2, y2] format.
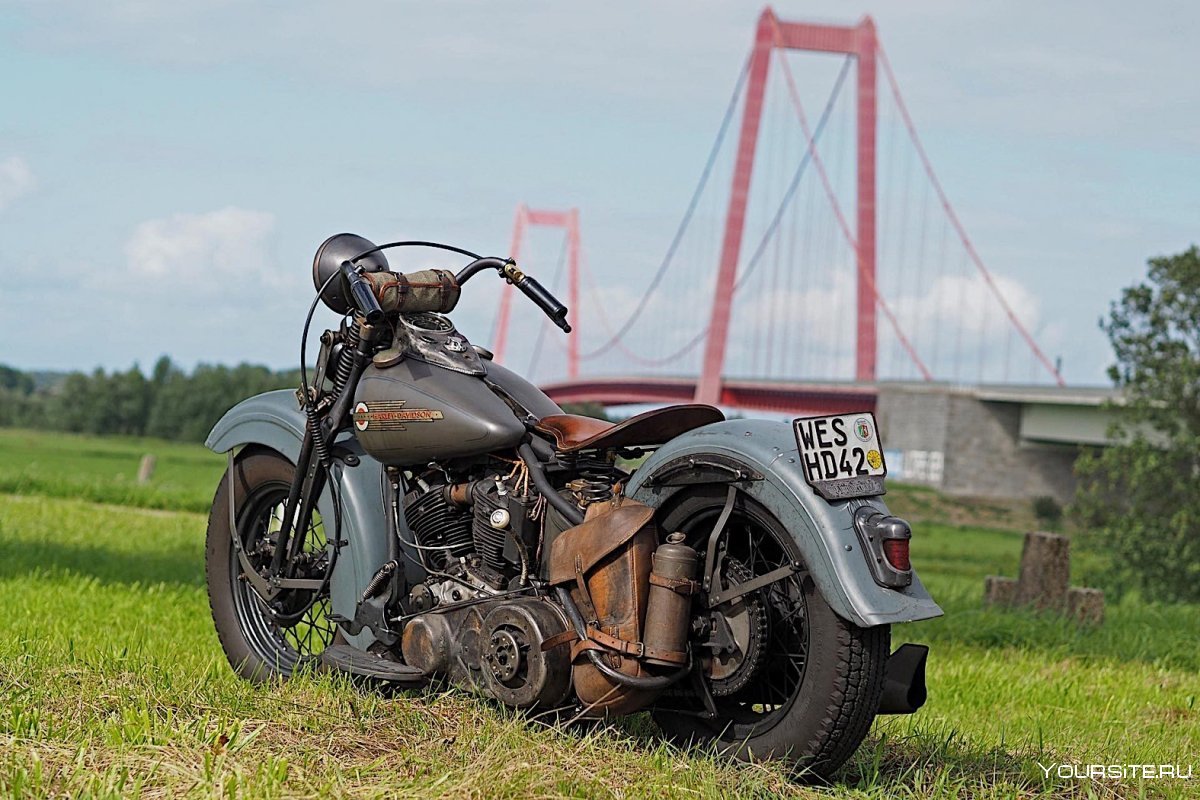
[695, 6, 877, 404]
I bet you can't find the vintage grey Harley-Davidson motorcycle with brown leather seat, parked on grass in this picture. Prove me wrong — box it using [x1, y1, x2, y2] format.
[205, 234, 942, 776]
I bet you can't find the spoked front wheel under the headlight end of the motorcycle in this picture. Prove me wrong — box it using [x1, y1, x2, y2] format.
[205, 452, 336, 681]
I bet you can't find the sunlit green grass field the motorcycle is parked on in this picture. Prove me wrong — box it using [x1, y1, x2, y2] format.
[0, 432, 1200, 798]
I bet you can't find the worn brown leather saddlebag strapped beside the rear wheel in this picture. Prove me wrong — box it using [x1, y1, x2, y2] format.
[550, 497, 661, 716]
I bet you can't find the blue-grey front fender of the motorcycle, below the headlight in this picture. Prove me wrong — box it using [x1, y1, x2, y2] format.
[204, 390, 393, 648]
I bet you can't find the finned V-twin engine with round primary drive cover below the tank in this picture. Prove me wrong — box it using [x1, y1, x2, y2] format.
[402, 465, 561, 708]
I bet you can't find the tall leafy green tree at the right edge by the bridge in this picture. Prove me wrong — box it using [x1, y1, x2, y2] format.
[1073, 246, 1200, 602]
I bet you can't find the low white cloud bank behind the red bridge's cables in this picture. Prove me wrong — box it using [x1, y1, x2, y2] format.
[487, 236, 1064, 383]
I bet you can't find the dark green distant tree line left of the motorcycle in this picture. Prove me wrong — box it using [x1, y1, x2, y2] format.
[0, 356, 300, 441]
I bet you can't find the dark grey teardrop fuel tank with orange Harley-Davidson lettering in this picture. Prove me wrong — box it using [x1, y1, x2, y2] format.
[352, 357, 526, 467]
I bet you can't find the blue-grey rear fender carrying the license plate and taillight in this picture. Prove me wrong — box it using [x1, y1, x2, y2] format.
[626, 420, 942, 627]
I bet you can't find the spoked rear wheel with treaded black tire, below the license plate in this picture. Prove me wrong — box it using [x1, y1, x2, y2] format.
[654, 486, 890, 778]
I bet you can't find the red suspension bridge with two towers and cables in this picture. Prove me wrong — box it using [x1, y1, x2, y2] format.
[492, 8, 1063, 413]
